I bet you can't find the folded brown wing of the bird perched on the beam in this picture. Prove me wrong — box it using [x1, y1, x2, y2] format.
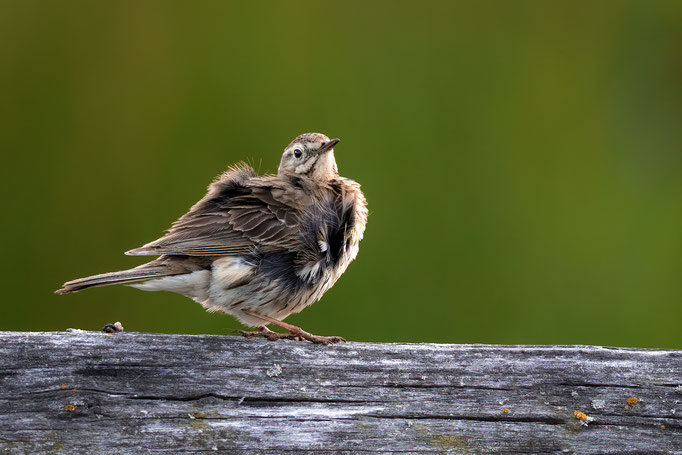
[126, 165, 299, 256]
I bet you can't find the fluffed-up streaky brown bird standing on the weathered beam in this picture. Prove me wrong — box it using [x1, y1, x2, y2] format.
[55, 133, 368, 345]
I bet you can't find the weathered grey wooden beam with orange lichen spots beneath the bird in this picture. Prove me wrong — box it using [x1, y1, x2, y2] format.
[0, 332, 682, 455]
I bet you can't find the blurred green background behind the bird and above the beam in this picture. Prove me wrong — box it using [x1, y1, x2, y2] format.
[0, 0, 682, 348]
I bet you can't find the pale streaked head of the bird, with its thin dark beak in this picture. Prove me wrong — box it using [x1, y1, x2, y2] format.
[277, 133, 339, 181]
